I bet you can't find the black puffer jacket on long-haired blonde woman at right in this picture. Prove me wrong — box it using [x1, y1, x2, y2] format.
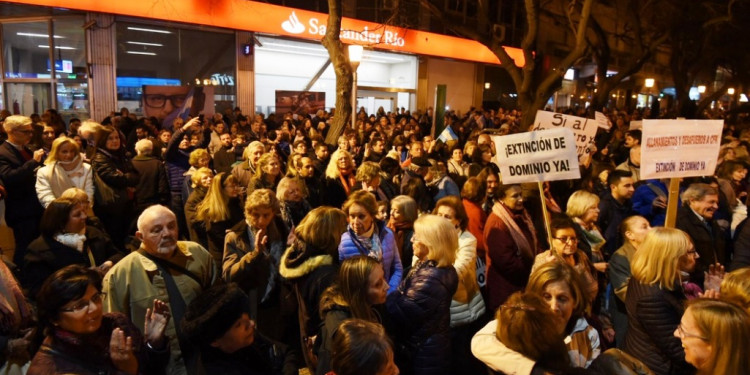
[624, 278, 695, 375]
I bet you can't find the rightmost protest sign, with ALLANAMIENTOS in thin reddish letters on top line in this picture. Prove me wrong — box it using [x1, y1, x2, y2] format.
[641, 120, 724, 180]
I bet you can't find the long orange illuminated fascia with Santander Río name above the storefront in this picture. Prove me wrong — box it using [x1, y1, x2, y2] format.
[6, 0, 525, 67]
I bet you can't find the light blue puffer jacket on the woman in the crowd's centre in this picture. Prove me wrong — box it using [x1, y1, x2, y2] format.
[339, 221, 403, 294]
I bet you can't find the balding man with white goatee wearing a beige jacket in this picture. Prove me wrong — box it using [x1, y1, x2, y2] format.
[102, 205, 220, 375]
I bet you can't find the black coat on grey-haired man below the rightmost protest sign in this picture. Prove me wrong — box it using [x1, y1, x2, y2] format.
[676, 206, 730, 287]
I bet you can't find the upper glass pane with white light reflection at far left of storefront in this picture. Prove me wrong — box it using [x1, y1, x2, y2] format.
[3, 21, 51, 78]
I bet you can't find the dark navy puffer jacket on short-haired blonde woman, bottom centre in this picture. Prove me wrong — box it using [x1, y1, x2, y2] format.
[386, 260, 458, 374]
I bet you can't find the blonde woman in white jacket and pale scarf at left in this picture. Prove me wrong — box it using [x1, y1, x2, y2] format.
[36, 137, 94, 208]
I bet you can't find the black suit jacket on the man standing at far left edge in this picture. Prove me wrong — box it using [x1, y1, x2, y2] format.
[0, 142, 44, 226]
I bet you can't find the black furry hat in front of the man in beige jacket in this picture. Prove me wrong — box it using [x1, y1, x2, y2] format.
[182, 283, 250, 346]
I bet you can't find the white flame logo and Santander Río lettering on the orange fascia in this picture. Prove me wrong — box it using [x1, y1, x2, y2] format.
[281, 11, 406, 47]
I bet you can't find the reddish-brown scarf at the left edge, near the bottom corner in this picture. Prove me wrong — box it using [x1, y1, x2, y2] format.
[0, 260, 31, 333]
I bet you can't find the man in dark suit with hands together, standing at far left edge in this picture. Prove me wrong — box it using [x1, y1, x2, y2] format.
[0, 116, 44, 267]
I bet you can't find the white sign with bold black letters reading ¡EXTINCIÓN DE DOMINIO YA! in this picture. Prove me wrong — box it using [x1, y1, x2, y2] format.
[492, 128, 581, 184]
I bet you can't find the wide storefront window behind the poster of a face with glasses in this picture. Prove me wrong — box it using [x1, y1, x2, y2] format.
[117, 22, 236, 128]
